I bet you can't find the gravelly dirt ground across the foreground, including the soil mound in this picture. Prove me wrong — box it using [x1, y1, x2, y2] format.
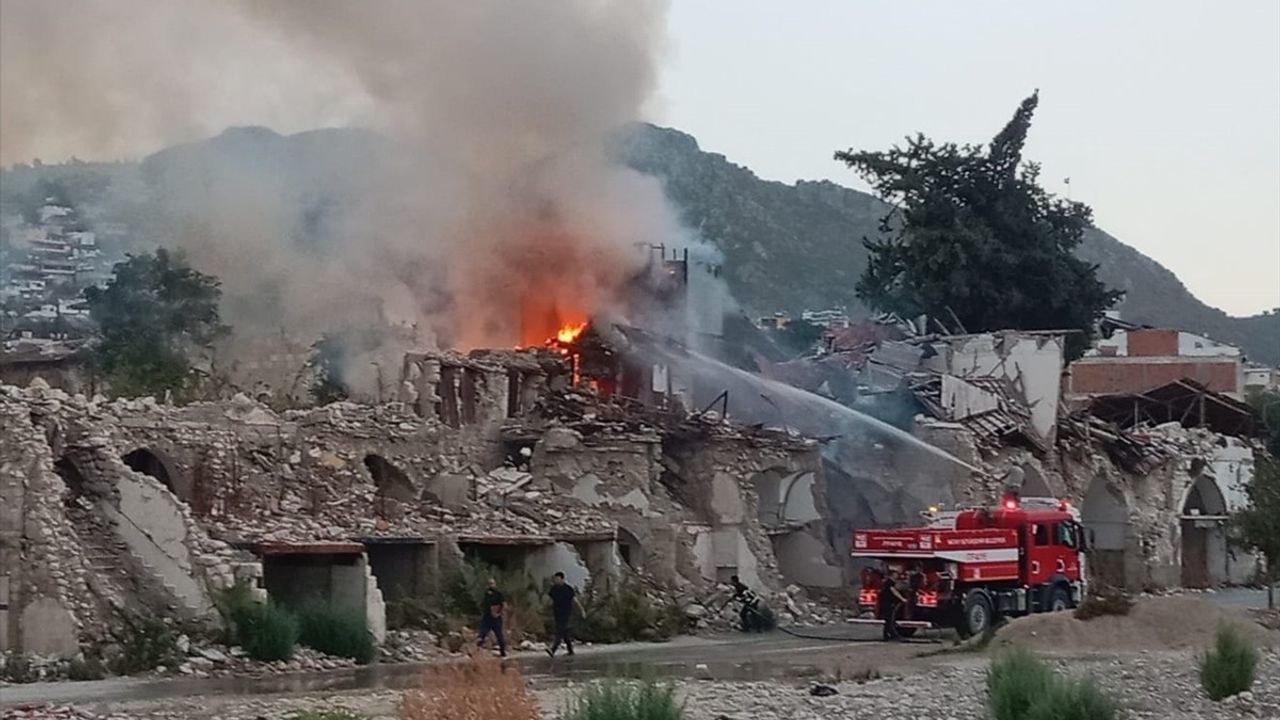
[0, 597, 1280, 720]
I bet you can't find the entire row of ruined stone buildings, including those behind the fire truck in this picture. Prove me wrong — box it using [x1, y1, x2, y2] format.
[0, 308, 1257, 655]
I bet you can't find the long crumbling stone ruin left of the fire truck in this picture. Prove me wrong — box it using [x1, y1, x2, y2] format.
[0, 340, 822, 655]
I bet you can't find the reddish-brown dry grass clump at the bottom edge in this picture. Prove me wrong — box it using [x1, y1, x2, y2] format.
[399, 652, 540, 720]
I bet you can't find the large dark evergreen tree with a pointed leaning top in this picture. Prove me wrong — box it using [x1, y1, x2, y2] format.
[836, 94, 1123, 356]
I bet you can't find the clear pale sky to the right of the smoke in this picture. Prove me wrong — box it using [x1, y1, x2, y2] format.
[654, 0, 1280, 314]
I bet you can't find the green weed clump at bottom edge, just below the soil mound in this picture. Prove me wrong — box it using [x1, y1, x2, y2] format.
[987, 650, 1120, 720]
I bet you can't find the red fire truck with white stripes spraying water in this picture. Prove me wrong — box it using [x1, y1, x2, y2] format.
[852, 492, 1091, 637]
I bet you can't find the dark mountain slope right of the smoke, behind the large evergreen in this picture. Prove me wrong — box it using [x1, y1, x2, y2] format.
[614, 126, 1280, 365]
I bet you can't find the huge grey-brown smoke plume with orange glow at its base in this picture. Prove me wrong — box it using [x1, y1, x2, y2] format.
[0, 0, 680, 392]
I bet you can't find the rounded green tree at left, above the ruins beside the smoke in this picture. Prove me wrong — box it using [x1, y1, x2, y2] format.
[84, 249, 227, 395]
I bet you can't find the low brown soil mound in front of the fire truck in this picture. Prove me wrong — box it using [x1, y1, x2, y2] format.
[992, 597, 1280, 652]
